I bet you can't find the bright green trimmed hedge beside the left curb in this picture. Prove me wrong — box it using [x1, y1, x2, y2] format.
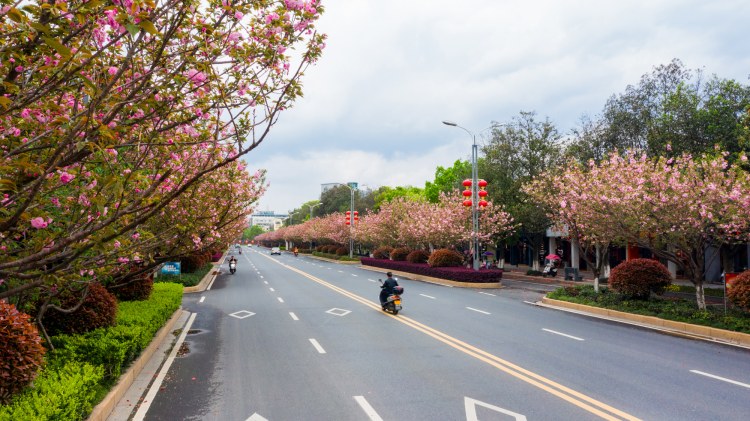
[0, 282, 183, 421]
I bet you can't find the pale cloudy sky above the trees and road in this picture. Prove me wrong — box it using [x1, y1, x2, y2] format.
[246, 0, 750, 213]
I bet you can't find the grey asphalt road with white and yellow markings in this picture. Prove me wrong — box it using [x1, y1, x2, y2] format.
[145, 248, 750, 421]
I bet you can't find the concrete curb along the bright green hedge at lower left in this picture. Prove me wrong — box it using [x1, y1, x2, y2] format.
[88, 308, 183, 421]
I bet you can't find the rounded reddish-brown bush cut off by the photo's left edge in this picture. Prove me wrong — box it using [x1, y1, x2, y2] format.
[0, 300, 44, 404]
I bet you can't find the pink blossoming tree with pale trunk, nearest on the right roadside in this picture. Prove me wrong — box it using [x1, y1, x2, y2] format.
[532, 149, 750, 309]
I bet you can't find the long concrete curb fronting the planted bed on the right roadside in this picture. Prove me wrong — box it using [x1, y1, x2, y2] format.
[540, 297, 750, 348]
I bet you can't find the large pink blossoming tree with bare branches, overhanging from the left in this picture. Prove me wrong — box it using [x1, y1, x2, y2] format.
[0, 0, 324, 308]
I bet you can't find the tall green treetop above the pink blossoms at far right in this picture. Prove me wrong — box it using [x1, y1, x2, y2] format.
[599, 59, 750, 156]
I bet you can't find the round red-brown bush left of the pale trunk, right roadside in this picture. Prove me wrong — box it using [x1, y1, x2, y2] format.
[609, 259, 672, 300]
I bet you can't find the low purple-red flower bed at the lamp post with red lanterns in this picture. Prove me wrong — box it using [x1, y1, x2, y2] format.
[361, 257, 503, 283]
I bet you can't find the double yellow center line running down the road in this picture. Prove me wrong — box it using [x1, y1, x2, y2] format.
[262, 255, 640, 421]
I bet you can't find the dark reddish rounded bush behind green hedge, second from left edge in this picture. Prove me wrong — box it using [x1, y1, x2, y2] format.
[42, 282, 117, 335]
